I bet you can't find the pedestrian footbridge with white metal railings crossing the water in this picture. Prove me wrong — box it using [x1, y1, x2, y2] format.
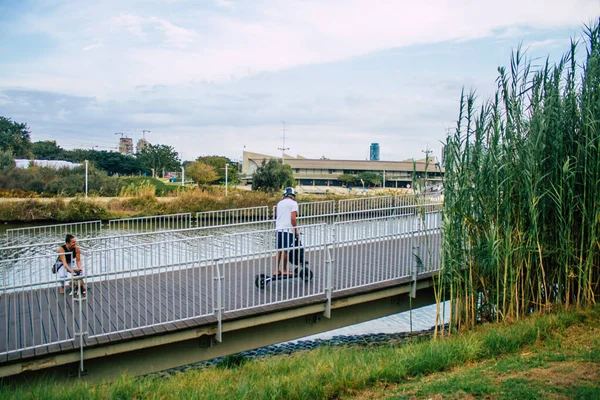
[0, 196, 441, 379]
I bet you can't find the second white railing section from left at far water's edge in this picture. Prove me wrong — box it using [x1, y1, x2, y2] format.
[108, 213, 192, 234]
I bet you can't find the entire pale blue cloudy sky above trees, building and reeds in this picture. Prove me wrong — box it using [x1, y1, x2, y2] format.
[0, 0, 600, 161]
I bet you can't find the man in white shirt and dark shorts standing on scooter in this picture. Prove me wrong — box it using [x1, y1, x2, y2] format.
[274, 187, 298, 275]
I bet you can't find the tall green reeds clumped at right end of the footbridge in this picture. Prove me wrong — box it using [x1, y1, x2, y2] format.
[438, 20, 600, 326]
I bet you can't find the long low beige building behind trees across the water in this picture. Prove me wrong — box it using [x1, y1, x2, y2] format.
[242, 151, 443, 188]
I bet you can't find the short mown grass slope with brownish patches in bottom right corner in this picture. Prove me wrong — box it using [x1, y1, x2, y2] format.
[342, 314, 600, 400]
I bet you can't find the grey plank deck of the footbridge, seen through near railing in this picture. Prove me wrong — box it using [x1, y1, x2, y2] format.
[0, 236, 437, 363]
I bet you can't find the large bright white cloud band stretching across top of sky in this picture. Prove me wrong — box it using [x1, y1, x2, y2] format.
[0, 0, 599, 95]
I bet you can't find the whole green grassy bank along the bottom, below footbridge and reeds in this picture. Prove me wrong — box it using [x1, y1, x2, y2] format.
[0, 307, 600, 399]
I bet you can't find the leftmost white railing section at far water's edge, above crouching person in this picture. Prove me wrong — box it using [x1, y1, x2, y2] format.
[6, 220, 102, 244]
